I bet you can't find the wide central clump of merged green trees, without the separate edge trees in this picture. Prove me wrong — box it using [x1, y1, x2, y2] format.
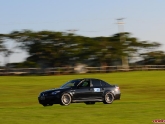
[0, 30, 160, 67]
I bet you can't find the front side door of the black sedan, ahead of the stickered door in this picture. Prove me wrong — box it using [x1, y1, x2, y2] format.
[73, 80, 93, 100]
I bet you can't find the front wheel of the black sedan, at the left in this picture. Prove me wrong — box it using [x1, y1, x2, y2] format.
[60, 93, 72, 106]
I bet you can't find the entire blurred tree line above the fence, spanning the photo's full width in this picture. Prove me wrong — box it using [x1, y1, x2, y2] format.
[0, 30, 165, 68]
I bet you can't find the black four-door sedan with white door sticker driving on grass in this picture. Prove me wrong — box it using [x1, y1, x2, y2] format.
[38, 78, 121, 106]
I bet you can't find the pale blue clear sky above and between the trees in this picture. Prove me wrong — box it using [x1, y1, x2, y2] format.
[0, 0, 165, 65]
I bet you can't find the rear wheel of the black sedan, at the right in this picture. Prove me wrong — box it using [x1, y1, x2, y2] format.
[103, 92, 114, 104]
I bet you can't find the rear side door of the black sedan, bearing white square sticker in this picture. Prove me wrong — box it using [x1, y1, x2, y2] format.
[91, 79, 104, 99]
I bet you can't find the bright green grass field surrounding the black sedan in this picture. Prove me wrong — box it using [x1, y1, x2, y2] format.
[0, 71, 165, 124]
